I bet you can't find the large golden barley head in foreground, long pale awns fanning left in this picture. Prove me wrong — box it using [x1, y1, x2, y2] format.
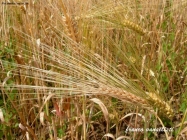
[1, 37, 173, 118]
